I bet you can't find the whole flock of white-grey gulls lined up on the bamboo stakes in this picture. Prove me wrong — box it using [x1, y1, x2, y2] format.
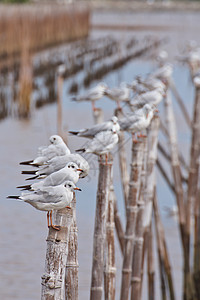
[8, 64, 172, 230]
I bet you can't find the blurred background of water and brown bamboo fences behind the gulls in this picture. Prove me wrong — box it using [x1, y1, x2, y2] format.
[0, 0, 200, 300]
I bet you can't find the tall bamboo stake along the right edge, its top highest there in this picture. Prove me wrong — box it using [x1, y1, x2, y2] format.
[186, 77, 200, 268]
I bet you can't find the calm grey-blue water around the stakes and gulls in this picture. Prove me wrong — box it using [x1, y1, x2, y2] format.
[0, 8, 199, 300]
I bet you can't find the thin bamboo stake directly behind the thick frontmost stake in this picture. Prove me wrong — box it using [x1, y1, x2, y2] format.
[65, 193, 79, 300]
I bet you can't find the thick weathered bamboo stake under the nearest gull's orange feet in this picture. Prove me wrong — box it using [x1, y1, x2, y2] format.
[41, 208, 73, 300]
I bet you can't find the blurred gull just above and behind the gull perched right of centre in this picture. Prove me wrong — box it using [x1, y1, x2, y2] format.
[129, 88, 165, 111]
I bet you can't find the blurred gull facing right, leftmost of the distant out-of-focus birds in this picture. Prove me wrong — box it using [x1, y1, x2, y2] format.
[72, 82, 107, 111]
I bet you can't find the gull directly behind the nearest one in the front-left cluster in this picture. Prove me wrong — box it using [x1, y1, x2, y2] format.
[17, 162, 82, 191]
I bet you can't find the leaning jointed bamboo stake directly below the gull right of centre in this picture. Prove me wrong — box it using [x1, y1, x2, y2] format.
[120, 142, 144, 300]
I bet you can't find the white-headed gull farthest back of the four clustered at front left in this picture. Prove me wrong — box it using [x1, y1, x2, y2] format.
[20, 135, 70, 166]
